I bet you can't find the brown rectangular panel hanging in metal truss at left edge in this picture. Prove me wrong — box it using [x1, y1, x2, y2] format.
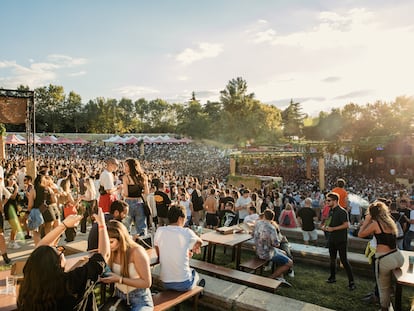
[0, 97, 27, 124]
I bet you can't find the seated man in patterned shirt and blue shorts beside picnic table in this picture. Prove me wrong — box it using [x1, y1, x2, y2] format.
[253, 209, 293, 287]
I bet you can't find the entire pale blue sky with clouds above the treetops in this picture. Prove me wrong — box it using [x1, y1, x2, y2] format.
[0, 0, 414, 115]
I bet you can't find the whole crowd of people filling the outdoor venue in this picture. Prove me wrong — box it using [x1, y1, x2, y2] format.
[0, 144, 414, 310]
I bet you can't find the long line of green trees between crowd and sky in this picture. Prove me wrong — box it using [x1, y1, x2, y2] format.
[2, 77, 414, 146]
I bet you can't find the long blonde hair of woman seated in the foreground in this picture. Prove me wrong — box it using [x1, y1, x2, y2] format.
[107, 220, 142, 277]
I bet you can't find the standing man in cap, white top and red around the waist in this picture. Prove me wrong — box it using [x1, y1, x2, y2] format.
[98, 158, 119, 213]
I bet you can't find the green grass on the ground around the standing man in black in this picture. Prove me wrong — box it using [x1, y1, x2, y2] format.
[194, 246, 414, 311]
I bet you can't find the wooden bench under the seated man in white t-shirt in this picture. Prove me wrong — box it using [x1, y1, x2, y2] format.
[152, 286, 204, 311]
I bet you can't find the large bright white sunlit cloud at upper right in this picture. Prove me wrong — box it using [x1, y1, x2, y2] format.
[247, 8, 414, 116]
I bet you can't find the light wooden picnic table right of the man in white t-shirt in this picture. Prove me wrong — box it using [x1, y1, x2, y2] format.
[200, 227, 252, 270]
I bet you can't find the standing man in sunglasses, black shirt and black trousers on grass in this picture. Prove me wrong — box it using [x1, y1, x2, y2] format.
[323, 192, 356, 290]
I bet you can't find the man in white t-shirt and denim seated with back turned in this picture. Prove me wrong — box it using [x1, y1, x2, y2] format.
[154, 205, 205, 291]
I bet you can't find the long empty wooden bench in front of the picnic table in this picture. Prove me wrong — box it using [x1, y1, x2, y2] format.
[190, 259, 281, 293]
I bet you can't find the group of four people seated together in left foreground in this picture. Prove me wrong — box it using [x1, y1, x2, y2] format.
[17, 201, 205, 311]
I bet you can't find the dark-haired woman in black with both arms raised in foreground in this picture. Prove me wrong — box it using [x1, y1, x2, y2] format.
[17, 208, 110, 311]
